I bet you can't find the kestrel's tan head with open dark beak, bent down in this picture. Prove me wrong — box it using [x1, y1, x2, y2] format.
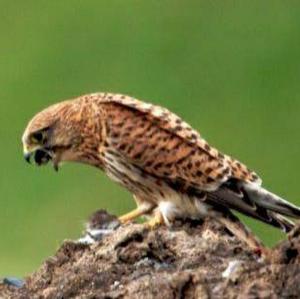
[22, 99, 97, 170]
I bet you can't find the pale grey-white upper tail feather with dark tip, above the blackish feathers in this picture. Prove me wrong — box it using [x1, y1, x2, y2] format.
[241, 183, 300, 218]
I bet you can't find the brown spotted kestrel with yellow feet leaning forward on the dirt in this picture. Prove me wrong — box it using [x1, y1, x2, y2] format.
[22, 93, 300, 255]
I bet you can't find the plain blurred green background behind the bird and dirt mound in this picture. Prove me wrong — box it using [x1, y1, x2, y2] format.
[0, 0, 300, 276]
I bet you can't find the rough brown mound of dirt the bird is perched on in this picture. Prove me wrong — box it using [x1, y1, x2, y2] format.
[0, 211, 300, 299]
